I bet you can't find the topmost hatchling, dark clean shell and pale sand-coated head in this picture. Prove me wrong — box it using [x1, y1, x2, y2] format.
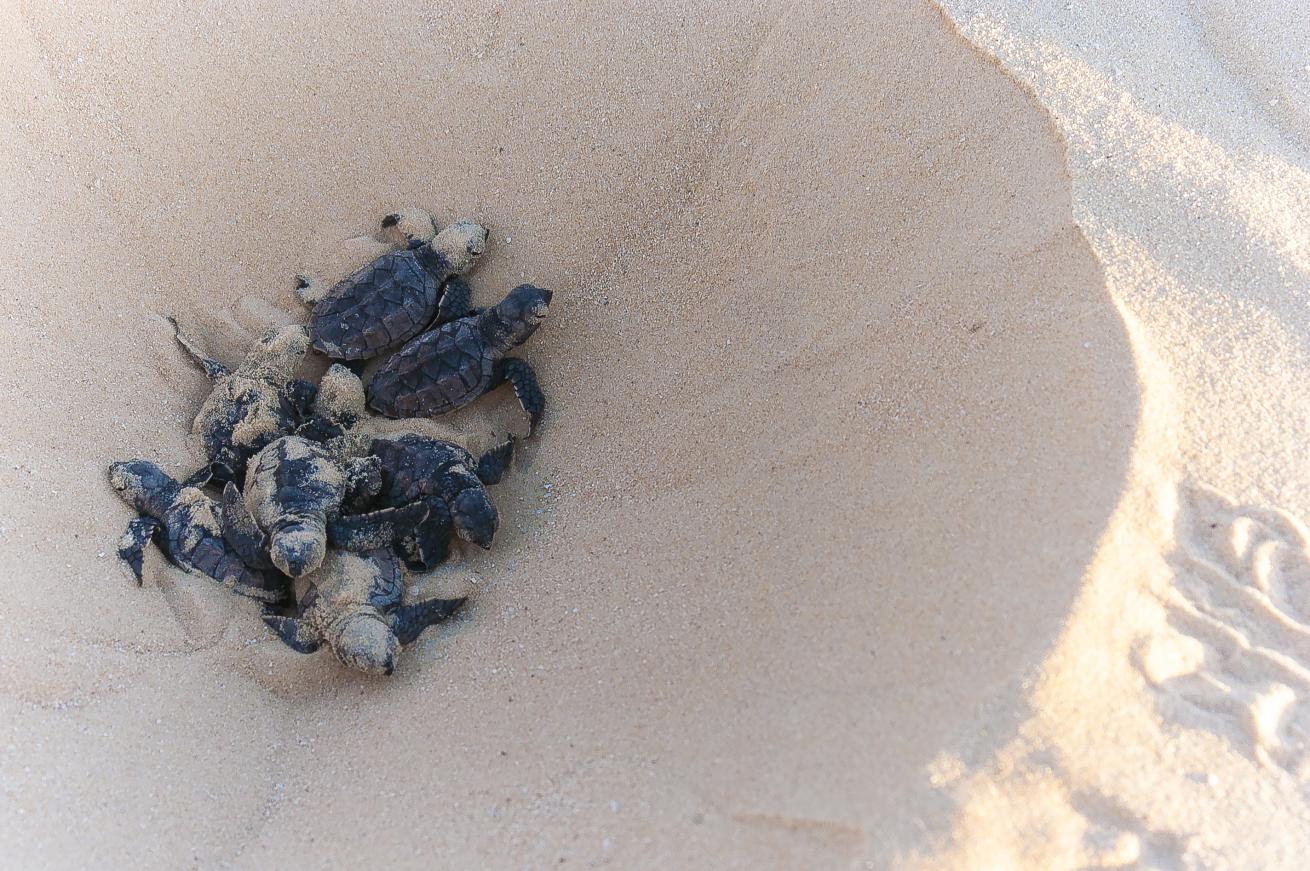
[296, 216, 487, 360]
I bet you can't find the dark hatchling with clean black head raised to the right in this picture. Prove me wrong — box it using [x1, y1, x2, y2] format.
[368, 284, 552, 432]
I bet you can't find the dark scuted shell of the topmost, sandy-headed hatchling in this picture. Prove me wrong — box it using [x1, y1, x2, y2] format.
[309, 251, 441, 360]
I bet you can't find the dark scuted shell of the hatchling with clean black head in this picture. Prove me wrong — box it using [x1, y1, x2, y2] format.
[368, 318, 495, 418]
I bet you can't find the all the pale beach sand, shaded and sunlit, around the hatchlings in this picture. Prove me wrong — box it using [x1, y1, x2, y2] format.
[0, 0, 1310, 868]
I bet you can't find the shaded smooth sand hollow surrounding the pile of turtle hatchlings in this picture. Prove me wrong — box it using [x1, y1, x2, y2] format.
[0, 3, 1138, 868]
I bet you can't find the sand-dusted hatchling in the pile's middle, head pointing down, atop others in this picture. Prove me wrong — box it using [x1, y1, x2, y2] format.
[223, 436, 427, 578]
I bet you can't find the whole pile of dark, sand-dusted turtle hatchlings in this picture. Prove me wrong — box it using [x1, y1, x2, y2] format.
[109, 210, 550, 675]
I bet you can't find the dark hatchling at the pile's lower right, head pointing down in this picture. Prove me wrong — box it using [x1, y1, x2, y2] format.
[369, 432, 514, 571]
